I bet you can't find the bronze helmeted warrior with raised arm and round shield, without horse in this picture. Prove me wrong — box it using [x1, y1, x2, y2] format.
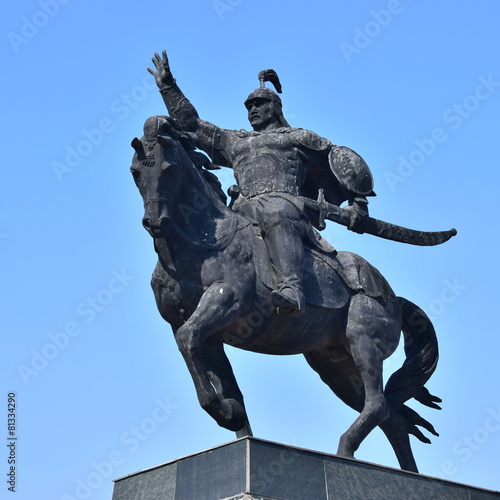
[148, 51, 374, 315]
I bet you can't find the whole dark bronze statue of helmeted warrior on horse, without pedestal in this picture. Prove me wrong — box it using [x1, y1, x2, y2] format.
[131, 52, 456, 471]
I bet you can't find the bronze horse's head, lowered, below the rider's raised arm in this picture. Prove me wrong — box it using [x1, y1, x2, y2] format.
[130, 116, 190, 238]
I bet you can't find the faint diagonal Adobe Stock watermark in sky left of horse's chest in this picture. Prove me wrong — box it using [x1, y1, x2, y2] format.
[17, 268, 134, 385]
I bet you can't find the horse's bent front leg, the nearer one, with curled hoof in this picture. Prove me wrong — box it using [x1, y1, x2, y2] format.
[175, 282, 248, 432]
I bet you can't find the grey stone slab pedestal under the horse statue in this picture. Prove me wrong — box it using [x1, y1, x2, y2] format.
[113, 438, 500, 500]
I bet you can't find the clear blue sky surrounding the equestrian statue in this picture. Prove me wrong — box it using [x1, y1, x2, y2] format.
[0, 0, 500, 500]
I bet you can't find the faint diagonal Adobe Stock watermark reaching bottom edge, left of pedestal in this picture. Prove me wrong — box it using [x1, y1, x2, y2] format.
[61, 397, 179, 500]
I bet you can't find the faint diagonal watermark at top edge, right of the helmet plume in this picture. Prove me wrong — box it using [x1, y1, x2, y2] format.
[339, 0, 411, 63]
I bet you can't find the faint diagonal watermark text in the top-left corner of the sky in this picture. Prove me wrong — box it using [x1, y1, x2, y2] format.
[7, 0, 70, 54]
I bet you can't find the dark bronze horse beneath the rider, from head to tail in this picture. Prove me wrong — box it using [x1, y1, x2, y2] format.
[131, 116, 440, 472]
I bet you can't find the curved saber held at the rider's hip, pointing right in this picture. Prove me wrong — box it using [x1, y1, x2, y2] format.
[303, 189, 457, 246]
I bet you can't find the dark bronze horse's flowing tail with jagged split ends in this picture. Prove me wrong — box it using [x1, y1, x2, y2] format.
[384, 297, 441, 443]
